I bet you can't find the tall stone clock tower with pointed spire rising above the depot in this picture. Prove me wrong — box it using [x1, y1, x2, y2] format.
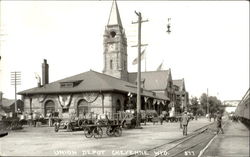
[103, 0, 128, 81]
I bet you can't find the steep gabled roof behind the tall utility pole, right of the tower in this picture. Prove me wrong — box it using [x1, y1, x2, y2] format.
[129, 70, 170, 91]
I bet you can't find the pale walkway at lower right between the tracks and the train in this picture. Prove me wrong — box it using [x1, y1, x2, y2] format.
[203, 121, 249, 157]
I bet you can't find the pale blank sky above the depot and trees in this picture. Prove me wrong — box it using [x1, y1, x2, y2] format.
[0, 0, 249, 101]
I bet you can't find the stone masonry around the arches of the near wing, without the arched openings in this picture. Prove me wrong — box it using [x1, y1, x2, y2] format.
[23, 93, 125, 116]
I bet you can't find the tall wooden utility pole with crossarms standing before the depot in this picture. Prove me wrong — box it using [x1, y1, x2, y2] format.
[132, 11, 148, 127]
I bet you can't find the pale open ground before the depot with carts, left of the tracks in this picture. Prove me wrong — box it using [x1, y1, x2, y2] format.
[0, 118, 212, 156]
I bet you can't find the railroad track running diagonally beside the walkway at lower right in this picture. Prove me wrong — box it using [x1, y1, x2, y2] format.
[128, 122, 226, 157]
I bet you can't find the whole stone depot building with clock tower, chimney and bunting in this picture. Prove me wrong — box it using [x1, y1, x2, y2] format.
[18, 1, 188, 116]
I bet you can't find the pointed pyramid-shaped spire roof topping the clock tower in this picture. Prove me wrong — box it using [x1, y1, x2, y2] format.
[108, 0, 122, 27]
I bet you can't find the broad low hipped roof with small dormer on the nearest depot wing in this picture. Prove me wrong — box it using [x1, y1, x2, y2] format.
[18, 70, 168, 100]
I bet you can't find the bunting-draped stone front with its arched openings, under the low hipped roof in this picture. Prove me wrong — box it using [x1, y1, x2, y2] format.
[23, 92, 125, 117]
